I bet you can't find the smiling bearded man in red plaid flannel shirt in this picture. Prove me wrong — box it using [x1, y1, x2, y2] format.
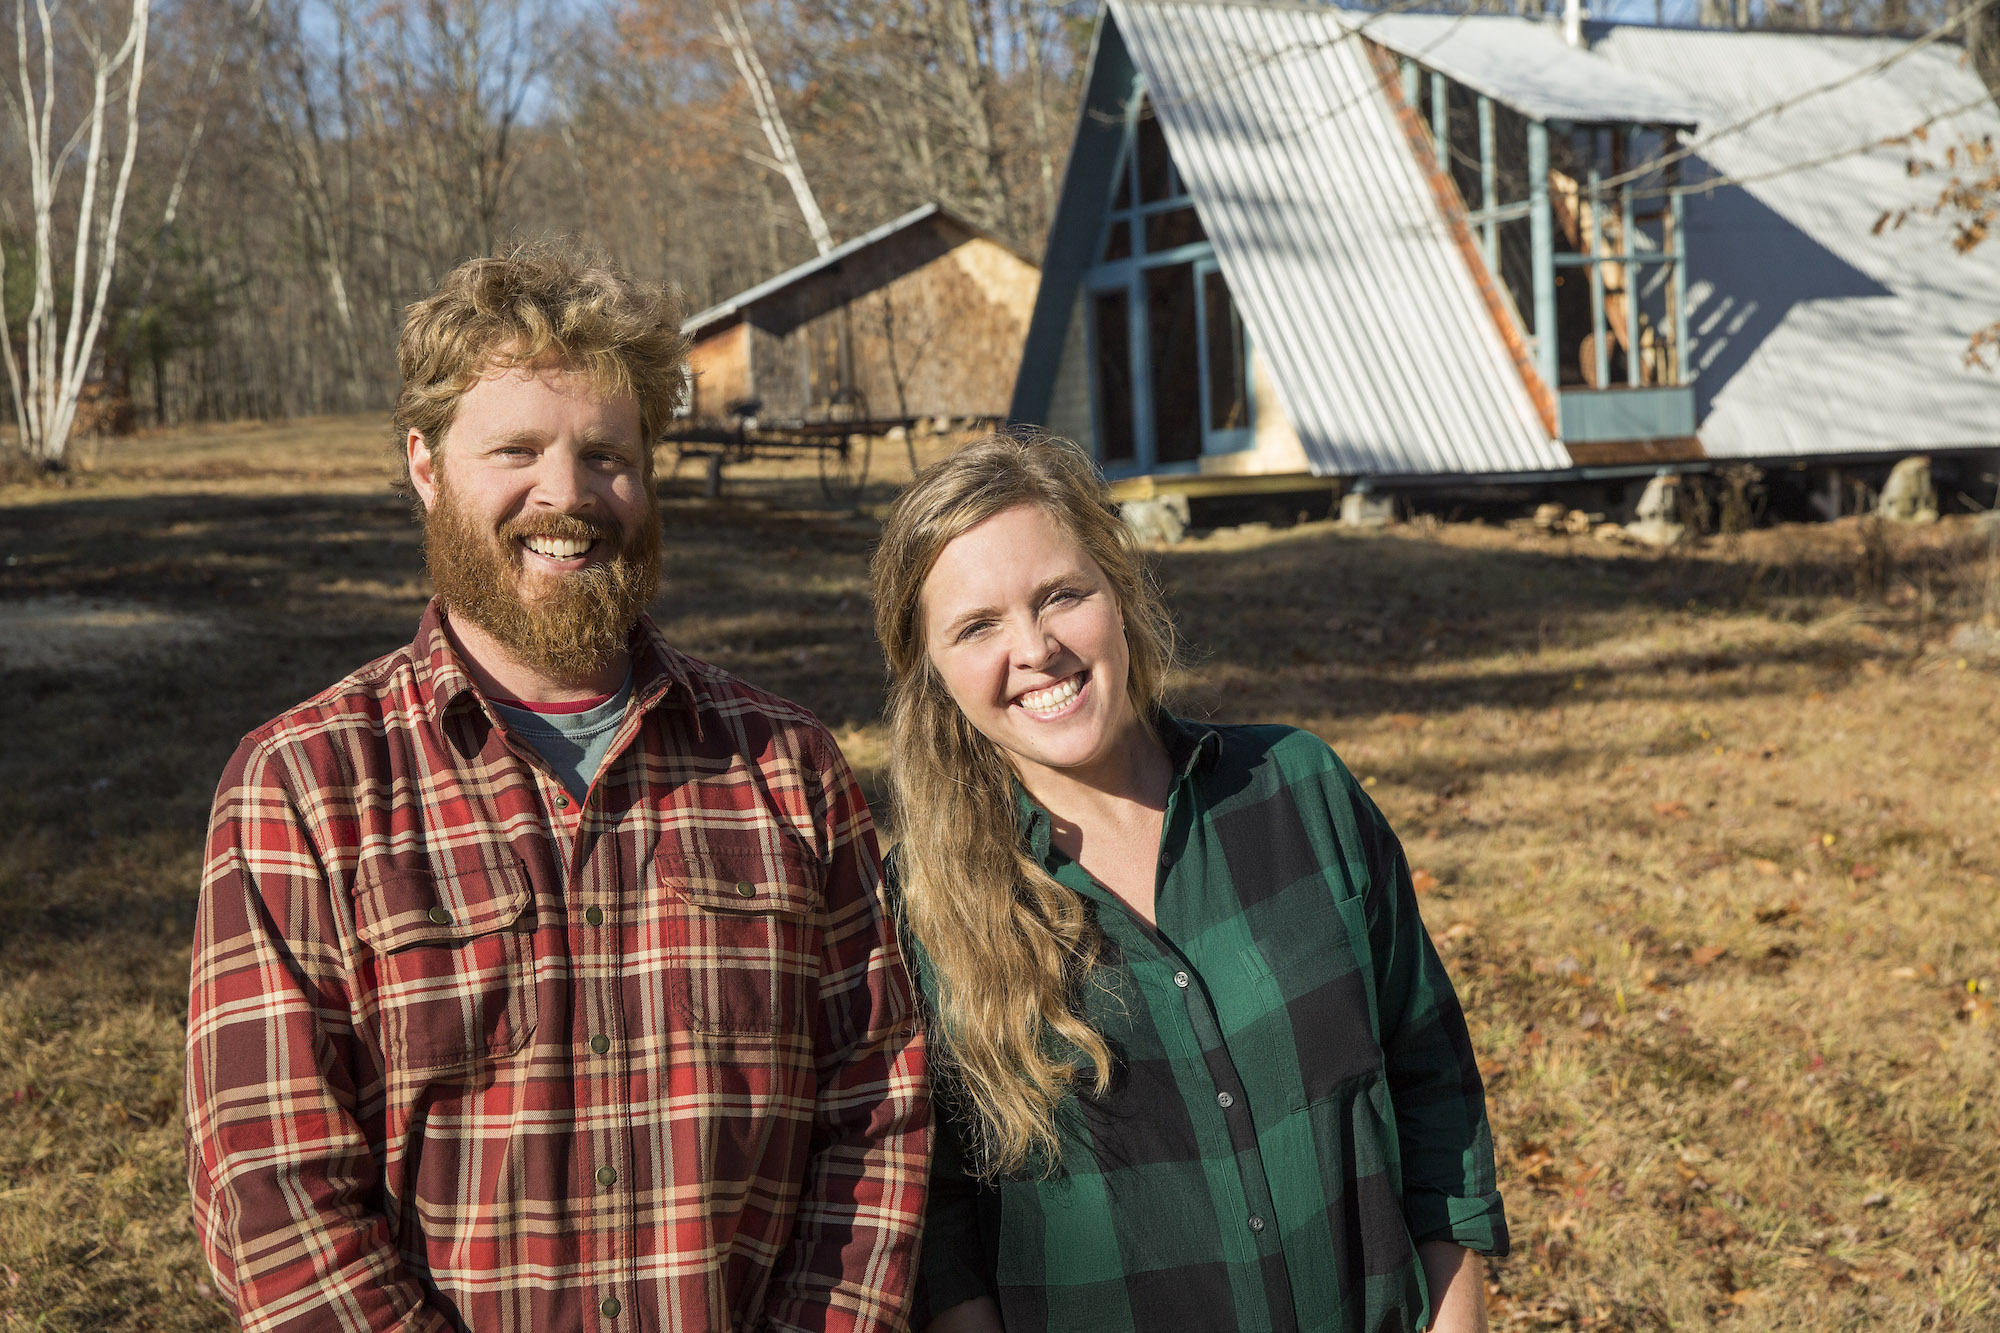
[188, 248, 928, 1333]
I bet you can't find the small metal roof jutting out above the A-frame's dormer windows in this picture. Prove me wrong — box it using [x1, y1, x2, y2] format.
[1348, 12, 1702, 126]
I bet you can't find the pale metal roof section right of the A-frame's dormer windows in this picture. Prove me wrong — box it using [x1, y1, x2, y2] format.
[1592, 26, 2000, 458]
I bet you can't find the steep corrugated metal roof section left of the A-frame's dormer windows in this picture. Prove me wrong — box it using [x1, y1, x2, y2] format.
[1110, 0, 1570, 476]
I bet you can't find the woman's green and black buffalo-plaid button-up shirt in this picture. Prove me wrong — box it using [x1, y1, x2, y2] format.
[892, 719, 1508, 1333]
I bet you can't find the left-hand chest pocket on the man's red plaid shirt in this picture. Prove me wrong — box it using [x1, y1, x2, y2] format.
[354, 863, 536, 1079]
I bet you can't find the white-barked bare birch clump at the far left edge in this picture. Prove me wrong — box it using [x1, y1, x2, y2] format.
[0, 0, 152, 468]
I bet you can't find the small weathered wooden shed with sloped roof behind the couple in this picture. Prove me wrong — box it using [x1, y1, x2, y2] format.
[686, 204, 1042, 426]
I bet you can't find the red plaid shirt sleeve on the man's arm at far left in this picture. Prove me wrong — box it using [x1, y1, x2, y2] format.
[186, 743, 446, 1333]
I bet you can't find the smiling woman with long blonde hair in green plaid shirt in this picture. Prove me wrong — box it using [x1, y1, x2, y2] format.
[874, 436, 1506, 1333]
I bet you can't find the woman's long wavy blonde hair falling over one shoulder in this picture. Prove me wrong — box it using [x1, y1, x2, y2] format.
[870, 434, 1174, 1177]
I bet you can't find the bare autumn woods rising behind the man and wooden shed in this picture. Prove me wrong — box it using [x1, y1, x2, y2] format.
[0, 0, 2000, 460]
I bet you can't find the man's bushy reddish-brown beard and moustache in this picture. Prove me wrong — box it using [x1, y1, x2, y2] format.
[424, 468, 660, 683]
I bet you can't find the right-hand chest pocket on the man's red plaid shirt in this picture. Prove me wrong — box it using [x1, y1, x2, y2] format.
[656, 839, 824, 1041]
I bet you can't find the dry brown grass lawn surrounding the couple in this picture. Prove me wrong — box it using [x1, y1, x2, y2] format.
[0, 420, 2000, 1331]
